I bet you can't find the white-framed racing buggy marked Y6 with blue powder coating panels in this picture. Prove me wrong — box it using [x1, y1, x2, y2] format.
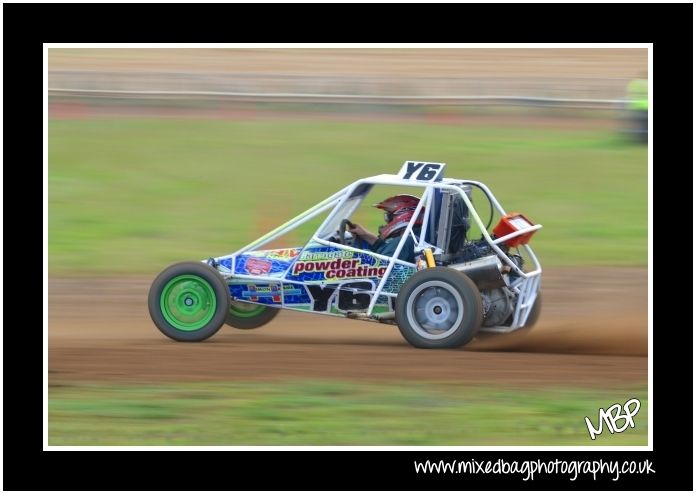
[148, 161, 541, 348]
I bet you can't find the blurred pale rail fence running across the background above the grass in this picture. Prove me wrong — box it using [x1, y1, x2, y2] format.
[48, 70, 630, 108]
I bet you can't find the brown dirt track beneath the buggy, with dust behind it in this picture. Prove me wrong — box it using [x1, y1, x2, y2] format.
[48, 268, 647, 386]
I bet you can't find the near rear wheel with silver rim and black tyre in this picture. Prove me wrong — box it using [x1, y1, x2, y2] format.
[395, 267, 483, 348]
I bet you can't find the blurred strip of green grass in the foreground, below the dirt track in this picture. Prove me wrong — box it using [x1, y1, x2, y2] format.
[48, 381, 648, 446]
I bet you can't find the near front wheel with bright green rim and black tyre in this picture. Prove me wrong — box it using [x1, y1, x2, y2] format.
[148, 262, 230, 341]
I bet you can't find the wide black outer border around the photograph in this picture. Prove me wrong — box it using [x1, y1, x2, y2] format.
[3, 4, 693, 491]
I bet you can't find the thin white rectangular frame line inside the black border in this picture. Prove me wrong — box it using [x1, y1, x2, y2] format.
[43, 43, 652, 452]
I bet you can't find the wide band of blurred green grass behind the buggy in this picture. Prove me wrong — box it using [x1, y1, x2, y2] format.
[48, 119, 648, 275]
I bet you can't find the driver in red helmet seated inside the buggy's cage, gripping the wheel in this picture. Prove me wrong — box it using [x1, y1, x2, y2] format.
[348, 194, 423, 262]
